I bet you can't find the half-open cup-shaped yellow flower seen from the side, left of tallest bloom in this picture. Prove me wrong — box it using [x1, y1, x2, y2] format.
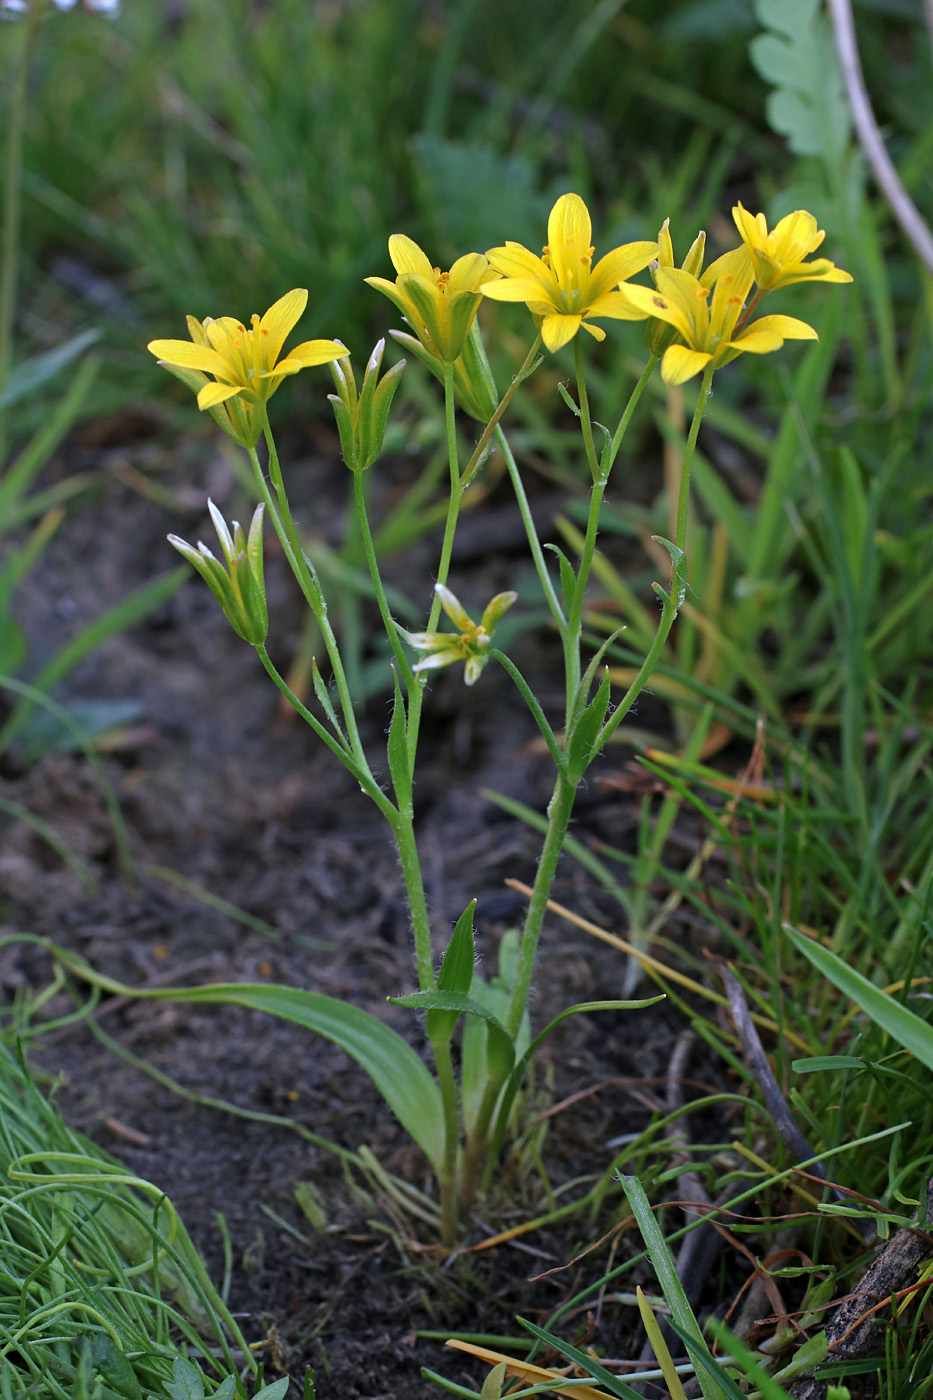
[364, 234, 496, 364]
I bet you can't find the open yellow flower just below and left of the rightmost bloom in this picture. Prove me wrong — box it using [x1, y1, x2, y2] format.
[628, 248, 817, 384]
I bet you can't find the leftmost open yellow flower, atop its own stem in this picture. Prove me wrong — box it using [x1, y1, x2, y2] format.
[148, 287, 350, 447]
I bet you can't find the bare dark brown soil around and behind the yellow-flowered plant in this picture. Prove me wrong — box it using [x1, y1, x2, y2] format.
[0, 420, 721, 1400]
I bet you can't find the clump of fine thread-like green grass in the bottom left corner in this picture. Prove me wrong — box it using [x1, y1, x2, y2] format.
[0, 1046, 255, 1400]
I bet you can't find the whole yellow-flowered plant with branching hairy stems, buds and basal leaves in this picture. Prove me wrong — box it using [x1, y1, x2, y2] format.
[141, 195, 850, 1243]
